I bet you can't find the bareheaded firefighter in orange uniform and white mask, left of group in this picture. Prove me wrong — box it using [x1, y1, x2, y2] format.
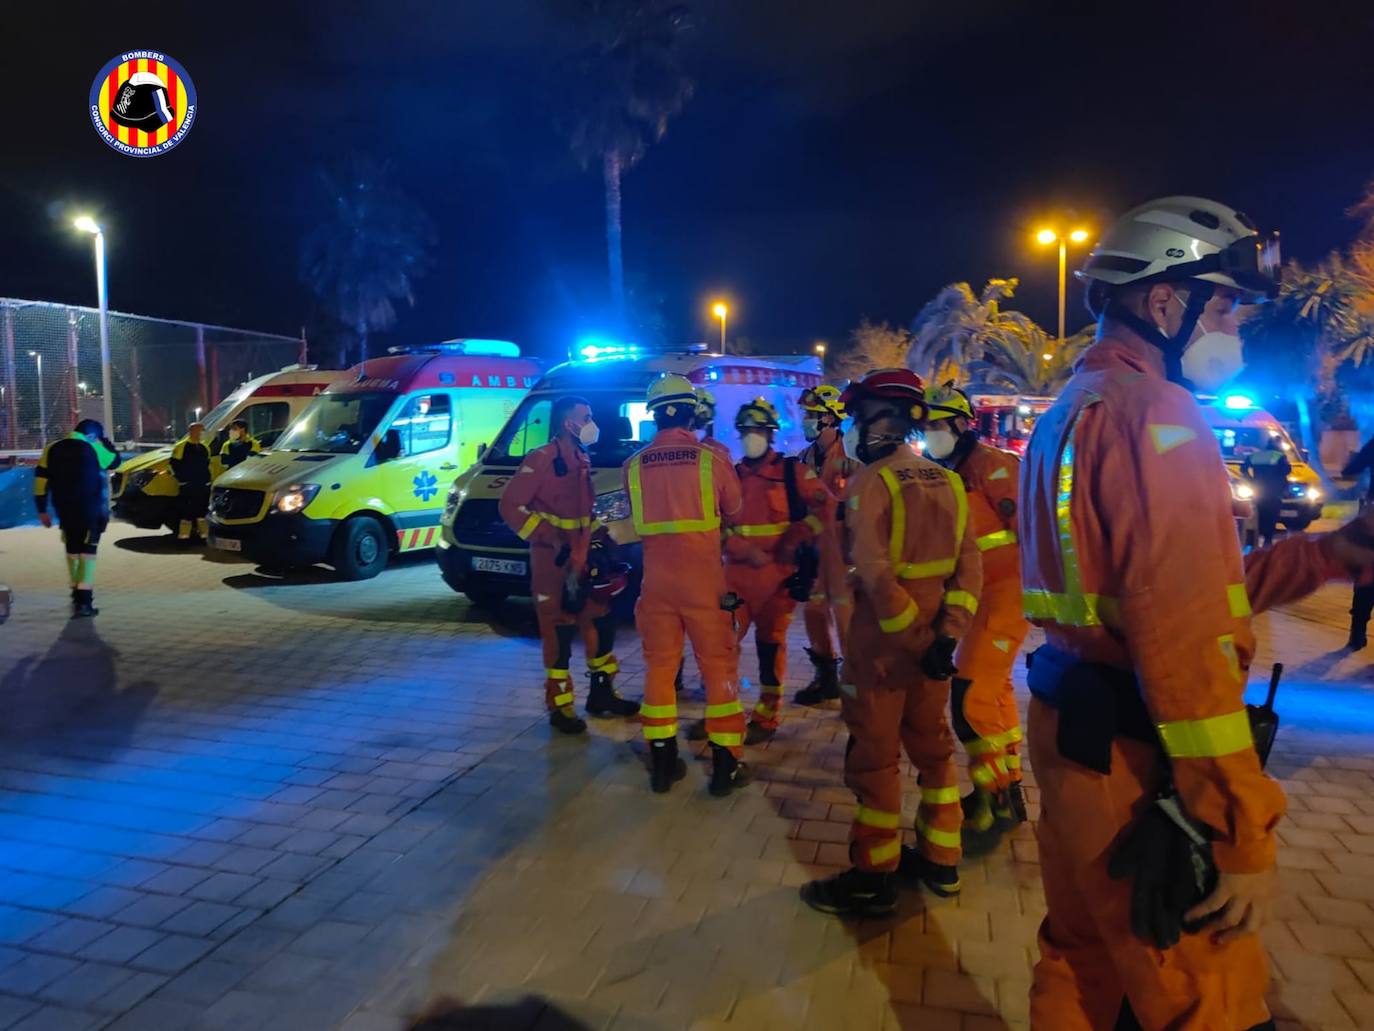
[500, 397, 639, 734]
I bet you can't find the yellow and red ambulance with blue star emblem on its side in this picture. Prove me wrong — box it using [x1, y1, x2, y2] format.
[209, 340, 540, 580]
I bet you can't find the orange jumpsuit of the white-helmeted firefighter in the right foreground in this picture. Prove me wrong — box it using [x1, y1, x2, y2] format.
[1020, 330, 1337, 1031]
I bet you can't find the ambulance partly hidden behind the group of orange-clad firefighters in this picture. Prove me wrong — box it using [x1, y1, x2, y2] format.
[437, 344, 822, 605]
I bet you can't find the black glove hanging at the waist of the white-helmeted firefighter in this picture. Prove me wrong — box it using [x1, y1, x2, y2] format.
[1107, 795, 1217, 949]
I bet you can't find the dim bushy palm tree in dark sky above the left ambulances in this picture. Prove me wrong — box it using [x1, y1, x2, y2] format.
[300, 154, 436, 360]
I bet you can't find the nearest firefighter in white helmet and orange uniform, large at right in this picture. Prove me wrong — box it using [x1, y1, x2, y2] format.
[1020, 197, 1370, 1031]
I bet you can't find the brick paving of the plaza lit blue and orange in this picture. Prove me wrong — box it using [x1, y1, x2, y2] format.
[0, 528, 1374, 1031]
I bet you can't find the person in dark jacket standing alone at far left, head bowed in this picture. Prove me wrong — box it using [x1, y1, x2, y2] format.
[33, 419, 120, 617]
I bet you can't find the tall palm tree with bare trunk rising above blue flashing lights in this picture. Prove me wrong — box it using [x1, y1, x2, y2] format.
[569, 0, 694, 327]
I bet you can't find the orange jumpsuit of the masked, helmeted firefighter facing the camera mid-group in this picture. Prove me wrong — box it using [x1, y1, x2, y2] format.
[725, 451, 835, 730]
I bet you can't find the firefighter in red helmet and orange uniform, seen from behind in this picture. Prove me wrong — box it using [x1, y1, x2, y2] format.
[801, 368, 982, 916]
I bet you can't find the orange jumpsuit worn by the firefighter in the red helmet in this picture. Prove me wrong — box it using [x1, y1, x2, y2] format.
[841, 447, 982, 870]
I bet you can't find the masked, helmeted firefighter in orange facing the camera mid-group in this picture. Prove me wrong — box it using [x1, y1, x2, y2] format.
[725, 397, 834, 745]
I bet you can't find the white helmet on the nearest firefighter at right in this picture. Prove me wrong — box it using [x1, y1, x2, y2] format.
[1076, 197, 1279, 307]
